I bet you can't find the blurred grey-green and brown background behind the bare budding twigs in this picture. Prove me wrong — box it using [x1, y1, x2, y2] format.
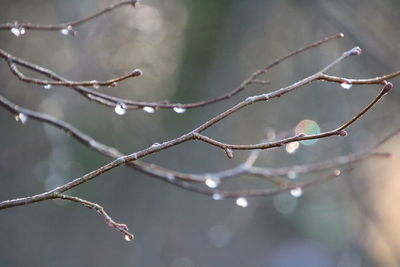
[0, 0, 400, 267]
